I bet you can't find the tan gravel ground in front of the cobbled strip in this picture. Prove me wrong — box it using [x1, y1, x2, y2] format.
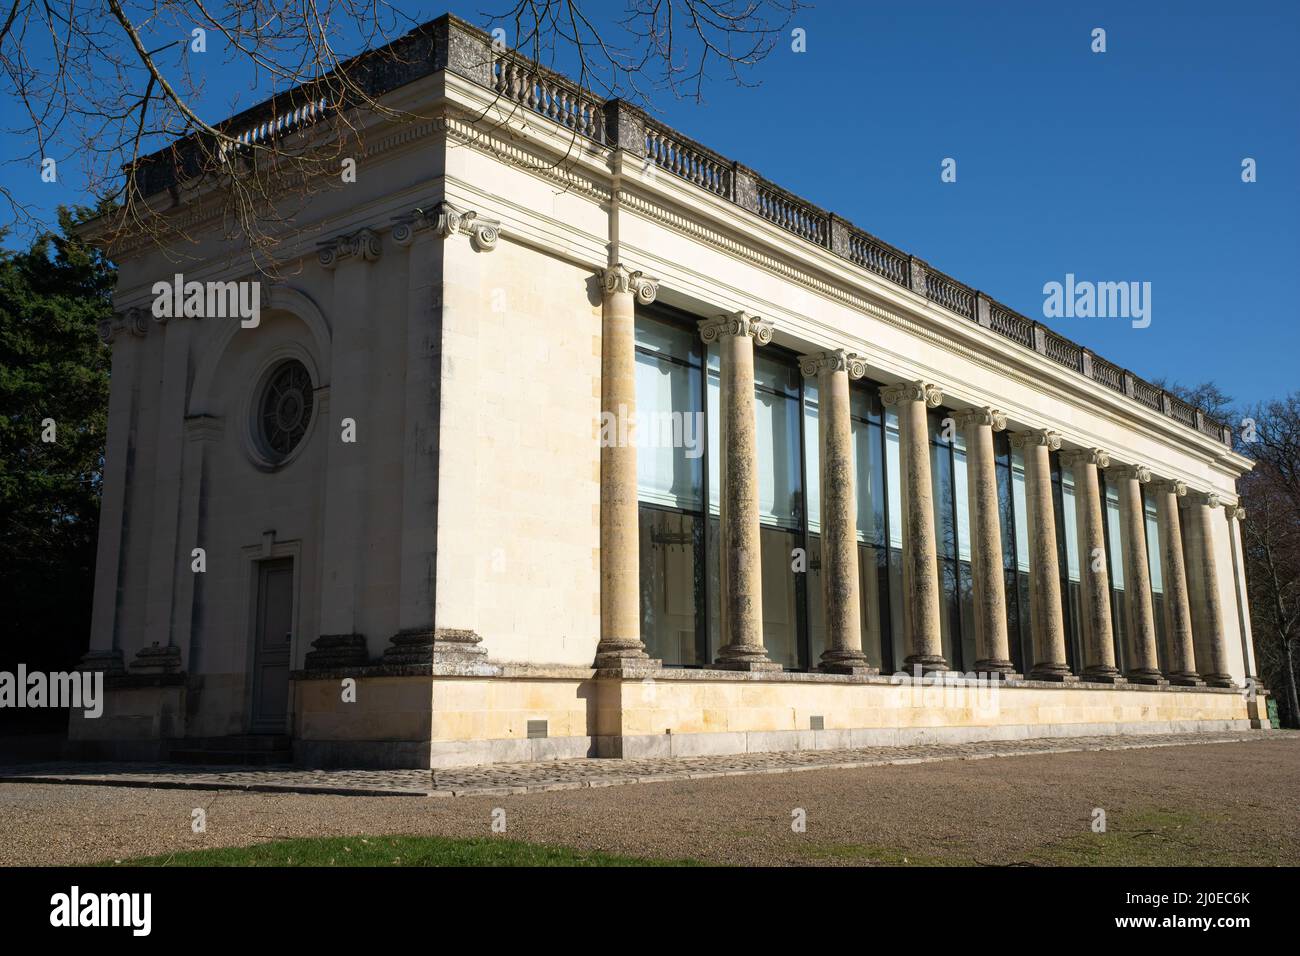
[0, 734, 1300, 865]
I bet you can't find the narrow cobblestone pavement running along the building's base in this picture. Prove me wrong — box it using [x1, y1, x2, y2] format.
[0, 731, 1279, 797]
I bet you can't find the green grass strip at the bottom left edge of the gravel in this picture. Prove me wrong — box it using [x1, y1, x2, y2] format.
[104, 836, 699, 866]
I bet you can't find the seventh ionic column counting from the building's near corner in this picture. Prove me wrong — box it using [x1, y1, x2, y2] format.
[1061, 449, 1126, 684]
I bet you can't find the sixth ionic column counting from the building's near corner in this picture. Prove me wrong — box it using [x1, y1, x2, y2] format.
[1011, 428, 1078, 682]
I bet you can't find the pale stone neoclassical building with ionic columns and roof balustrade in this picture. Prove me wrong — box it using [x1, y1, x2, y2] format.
[72, 17, 1258, 766]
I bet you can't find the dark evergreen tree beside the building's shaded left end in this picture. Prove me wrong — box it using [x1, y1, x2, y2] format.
[0, 209, 114, 723]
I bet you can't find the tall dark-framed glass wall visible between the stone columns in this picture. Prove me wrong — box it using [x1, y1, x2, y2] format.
[636, 306, 1080, 674]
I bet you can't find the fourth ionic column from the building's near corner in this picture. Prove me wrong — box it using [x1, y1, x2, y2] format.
[880, 381, 950, 672]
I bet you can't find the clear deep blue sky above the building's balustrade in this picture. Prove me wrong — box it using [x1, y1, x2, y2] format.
[0, 0, 1300, 402]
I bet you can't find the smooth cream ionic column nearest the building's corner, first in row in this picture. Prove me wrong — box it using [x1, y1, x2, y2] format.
[595, 263, 660, 669]
